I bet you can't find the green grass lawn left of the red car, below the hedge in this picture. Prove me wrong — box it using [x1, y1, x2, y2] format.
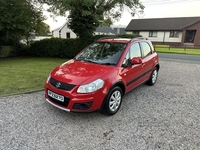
[0, 58, 66, 96]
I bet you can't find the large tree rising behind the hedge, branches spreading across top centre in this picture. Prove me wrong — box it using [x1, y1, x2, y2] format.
[38, 0, 144, 38]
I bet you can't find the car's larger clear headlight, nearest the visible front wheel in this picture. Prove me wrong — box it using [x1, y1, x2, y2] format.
[77, 79, 104, 93]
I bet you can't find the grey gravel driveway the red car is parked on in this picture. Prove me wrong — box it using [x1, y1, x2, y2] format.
[0, 60, 200, 150]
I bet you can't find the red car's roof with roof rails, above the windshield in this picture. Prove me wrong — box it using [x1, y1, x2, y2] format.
[97, 37, 147, 43]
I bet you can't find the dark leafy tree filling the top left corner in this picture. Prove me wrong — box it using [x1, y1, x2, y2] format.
[0, 0, 44, 45]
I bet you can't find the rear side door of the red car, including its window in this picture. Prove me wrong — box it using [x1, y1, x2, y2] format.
[140, 42, 154, 80]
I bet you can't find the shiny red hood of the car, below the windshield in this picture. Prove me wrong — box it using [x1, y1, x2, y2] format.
[51, 60, 115, 85]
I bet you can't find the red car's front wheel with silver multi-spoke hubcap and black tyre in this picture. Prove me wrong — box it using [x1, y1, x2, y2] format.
[102, 86, 123, 116]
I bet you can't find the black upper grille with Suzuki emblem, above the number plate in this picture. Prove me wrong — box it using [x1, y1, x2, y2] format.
[49, 78, 76, 91]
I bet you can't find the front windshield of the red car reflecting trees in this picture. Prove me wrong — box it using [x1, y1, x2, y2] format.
[75, 42, 126, 65]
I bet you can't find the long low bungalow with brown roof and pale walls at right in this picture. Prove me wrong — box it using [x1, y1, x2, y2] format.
[125, 17, 200, 46]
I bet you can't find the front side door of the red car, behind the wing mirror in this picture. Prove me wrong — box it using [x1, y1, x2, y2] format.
[121, 43, 143, 92]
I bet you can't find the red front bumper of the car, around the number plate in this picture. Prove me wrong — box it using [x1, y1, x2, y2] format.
[45, 83, 106, 112]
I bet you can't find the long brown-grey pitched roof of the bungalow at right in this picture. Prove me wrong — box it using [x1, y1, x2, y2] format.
[125, 17, 200, 31]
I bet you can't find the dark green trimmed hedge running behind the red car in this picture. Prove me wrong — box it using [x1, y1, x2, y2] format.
[20, 35, 141, 58]
